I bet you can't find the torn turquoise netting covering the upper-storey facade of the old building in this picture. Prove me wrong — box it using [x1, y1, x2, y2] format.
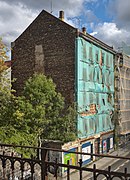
[76, 36, 114, 138]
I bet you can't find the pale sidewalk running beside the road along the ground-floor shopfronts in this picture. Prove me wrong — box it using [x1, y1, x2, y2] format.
[62, 148, 130, 180]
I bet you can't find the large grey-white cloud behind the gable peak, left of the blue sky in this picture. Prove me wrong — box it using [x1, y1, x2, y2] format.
[0, 0, 88, 44]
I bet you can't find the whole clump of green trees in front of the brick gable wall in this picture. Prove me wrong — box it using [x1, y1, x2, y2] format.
[0, 74, 76, 152]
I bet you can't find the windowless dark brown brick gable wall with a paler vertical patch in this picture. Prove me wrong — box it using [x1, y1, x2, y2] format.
[12, 11, 76, 102]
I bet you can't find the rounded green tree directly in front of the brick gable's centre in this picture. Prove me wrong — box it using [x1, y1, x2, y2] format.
[20, 74, 76, 142]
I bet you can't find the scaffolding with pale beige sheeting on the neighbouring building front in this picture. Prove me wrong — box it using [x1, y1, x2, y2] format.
[117, 53, 130, 135]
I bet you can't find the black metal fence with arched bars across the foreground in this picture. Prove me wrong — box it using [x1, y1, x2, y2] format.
[0, 144, 130, 180]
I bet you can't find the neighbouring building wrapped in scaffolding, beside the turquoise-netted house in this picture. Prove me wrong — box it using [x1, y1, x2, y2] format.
[115, 51, 130, 142]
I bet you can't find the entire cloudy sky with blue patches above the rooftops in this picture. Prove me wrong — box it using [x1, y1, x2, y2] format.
[0, 0, 130, 51]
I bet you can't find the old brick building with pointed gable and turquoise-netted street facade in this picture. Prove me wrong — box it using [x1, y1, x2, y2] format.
[12, 10, 116, 163]
